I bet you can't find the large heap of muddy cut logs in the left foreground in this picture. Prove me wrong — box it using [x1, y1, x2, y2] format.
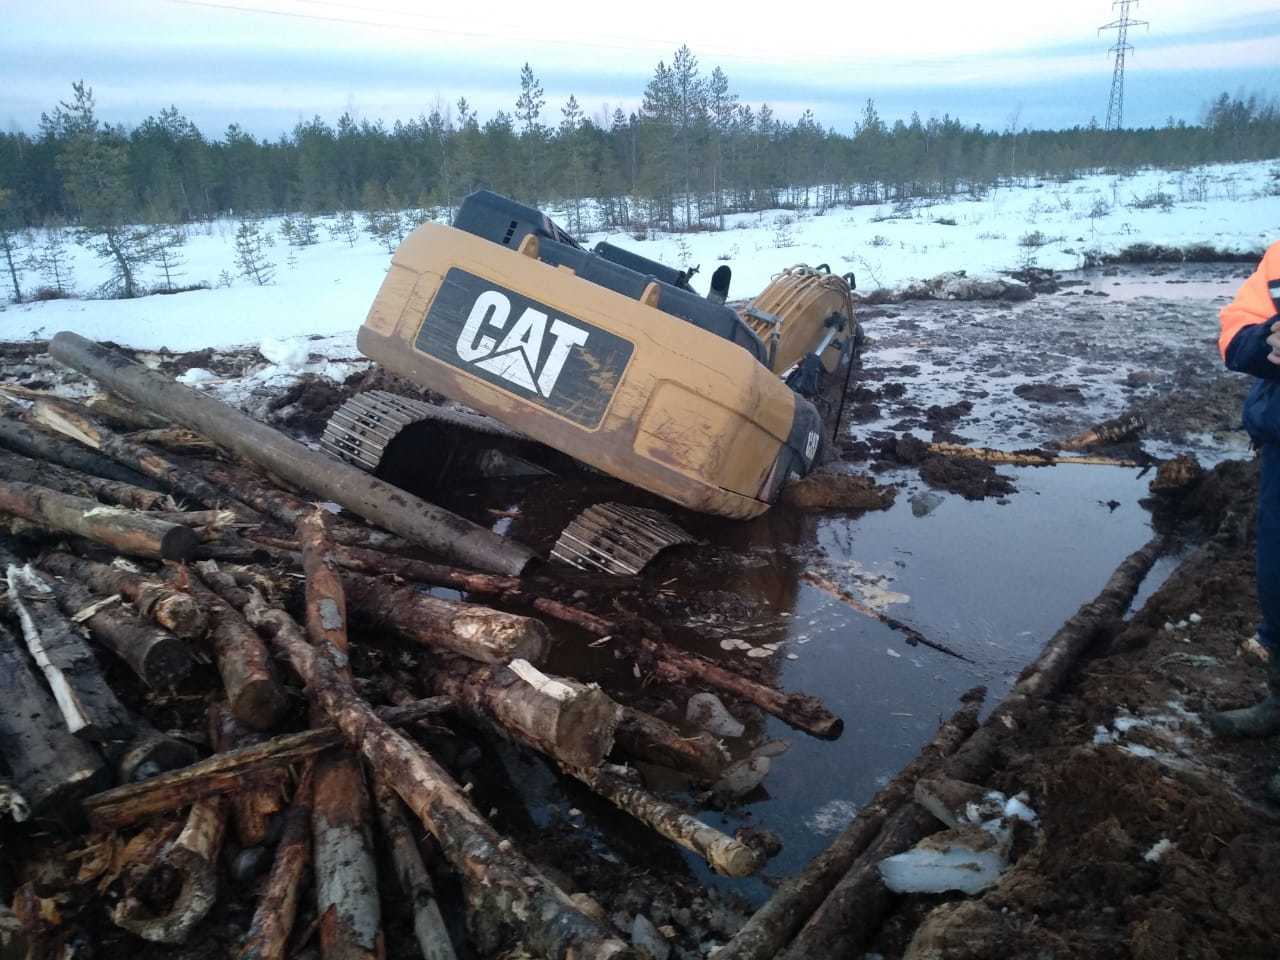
[0, 334, 841, 959]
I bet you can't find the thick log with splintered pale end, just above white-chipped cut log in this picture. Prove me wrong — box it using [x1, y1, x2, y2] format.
[343, 573, 550, 663]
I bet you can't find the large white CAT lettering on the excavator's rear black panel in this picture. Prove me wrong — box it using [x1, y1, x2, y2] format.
[457, 289, 590, 397]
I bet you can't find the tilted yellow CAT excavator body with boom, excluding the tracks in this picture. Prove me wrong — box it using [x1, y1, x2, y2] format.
[338, 192, 852, 518]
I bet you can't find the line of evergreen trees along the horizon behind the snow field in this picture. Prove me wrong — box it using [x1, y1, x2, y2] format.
[0, 46, 1280, 296]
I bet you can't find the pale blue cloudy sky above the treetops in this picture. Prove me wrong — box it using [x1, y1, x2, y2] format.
[0, 0, 1280, 137]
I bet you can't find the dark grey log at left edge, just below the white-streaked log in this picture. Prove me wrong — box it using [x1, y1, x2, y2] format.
[0, 623, 111, 819]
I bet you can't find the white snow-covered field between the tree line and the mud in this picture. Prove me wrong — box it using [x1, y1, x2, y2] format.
[0, 161, 1280, 355]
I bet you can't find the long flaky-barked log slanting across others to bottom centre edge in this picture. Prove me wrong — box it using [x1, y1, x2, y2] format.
[238, 591, 640, 960]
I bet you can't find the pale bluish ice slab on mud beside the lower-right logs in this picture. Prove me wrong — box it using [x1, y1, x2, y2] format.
[879, 827, 1009, 893]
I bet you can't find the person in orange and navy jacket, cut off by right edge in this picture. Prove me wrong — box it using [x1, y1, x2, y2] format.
[1210, 243, 1280, 791]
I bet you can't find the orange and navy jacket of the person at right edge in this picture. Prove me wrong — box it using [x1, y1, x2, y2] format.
[1217, 243, 1280, 443]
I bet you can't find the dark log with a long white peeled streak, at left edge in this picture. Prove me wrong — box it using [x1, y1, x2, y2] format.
[0, 560, 134, 740]
